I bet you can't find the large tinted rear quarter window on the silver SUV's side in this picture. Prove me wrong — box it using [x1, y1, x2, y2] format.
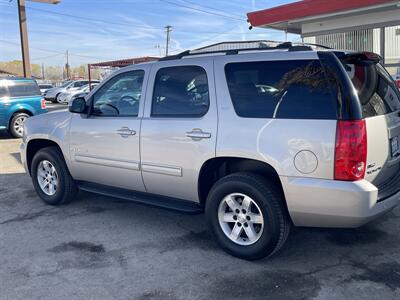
[225, 60, 337, 119]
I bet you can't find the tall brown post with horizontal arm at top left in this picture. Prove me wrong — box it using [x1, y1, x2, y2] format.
[18, 0, 61, 77]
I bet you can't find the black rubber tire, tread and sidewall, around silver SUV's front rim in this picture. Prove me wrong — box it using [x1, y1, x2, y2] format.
[31, 147, 78, 205]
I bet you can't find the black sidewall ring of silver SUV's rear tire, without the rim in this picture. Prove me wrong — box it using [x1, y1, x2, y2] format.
[206, 177, 280, 260]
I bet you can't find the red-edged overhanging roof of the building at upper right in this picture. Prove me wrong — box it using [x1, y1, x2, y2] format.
[247, 0, 400, 34]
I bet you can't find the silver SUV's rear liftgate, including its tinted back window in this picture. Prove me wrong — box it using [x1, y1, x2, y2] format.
[346, 61, 400, 199]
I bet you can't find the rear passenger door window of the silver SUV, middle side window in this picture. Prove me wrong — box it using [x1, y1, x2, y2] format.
[151, 66, 210, 118]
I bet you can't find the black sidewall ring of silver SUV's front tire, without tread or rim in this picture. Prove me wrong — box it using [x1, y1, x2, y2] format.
[31, 150, 66, 205]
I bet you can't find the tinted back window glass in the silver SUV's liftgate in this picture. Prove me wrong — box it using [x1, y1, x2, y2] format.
[345, 64, 400, 118]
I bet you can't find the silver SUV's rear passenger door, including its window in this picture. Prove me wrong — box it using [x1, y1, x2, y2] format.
[141, 59, 217, 201]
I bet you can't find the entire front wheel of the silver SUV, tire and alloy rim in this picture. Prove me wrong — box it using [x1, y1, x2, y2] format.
[31, 147, 78, 205]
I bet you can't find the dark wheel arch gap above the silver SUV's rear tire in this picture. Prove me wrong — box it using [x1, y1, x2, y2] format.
[198, 157, 287, 210]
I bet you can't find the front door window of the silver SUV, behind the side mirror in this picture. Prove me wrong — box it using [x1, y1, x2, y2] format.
[93, 70, 144, 117]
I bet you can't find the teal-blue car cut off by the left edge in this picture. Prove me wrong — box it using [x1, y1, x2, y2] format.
[0, 77, 47, 138]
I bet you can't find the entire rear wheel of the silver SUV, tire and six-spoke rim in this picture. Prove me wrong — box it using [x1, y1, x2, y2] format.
[206, 173, 291, 260]
